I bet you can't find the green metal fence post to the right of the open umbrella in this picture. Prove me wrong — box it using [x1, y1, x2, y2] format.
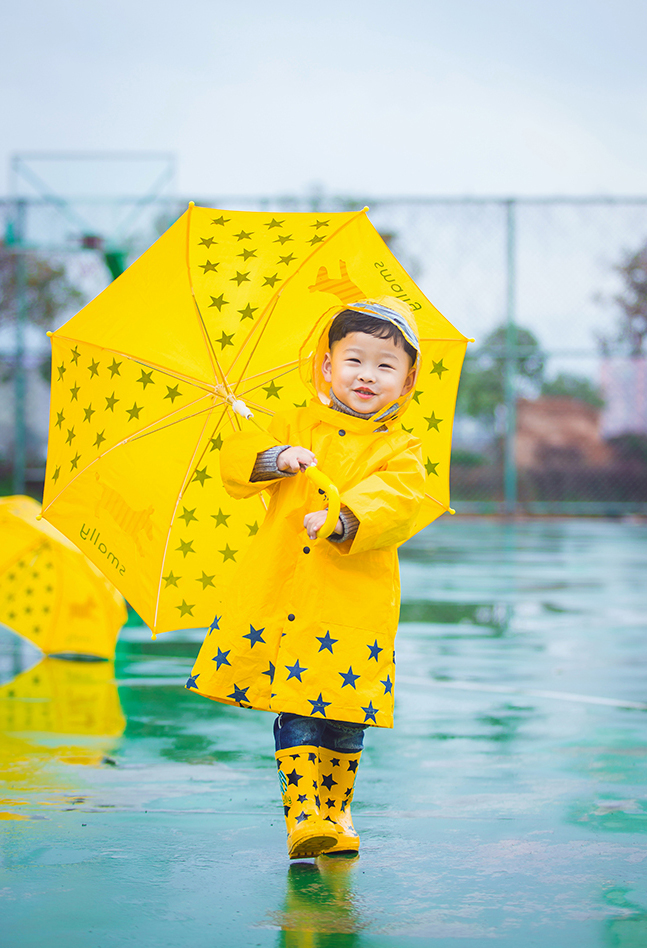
[503, 198, 517, 516]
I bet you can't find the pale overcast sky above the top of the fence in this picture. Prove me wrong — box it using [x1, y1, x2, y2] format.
[0, 0, 647, 197]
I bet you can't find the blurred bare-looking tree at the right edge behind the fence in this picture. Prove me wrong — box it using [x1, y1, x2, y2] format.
[598, 241, 647, 358]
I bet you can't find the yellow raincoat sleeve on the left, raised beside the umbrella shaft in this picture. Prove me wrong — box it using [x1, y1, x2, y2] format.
[220, 415, 290, 500]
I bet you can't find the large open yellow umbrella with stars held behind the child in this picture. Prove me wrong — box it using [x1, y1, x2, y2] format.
[43, 206, 467, 632]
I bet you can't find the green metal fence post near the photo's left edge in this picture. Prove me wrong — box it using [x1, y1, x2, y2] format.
[13, 201, 27, 494]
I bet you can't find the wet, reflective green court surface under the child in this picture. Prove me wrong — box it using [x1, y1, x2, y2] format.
[0, 518, 647, 948]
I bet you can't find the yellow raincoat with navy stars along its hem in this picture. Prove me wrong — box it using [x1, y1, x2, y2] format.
[187, 304, 425, 727]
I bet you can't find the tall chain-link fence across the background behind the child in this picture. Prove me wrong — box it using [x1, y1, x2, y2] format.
[0, 195, 647, 515]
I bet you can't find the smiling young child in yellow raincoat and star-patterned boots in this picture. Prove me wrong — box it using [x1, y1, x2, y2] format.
[187, 297, 425, 859]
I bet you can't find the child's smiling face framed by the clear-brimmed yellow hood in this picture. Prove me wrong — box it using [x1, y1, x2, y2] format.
[321, 332, 414, 414]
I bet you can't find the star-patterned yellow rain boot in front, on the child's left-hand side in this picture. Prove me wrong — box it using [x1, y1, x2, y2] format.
[276, 745, 338, 859]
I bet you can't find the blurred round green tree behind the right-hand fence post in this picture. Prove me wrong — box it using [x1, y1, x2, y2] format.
[457, 326, 545, 421]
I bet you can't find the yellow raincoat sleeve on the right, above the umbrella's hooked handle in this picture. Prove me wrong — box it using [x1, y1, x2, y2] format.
[339, 442, 425, 554]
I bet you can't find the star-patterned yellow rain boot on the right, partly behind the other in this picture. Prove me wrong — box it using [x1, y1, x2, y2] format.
[319, 747, 362, 855]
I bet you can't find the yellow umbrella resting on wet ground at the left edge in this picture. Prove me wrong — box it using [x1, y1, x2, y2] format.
[0, 497, 127, 658]
